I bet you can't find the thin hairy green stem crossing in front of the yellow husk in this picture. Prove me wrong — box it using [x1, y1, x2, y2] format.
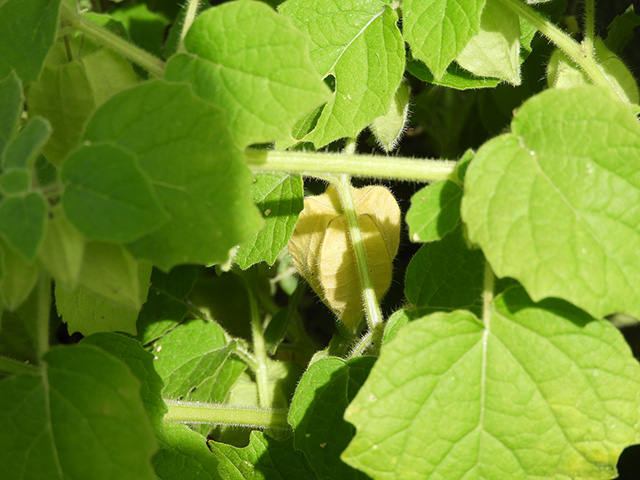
[333, 174, 384, 347]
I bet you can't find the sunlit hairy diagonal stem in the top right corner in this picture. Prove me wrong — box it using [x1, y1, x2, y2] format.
[500, 0, 626, 103]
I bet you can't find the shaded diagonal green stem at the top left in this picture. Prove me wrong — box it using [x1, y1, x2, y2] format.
[62, 2, 165, 77]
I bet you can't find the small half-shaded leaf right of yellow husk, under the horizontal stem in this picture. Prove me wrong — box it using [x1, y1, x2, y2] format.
[405, 180, 462, 242]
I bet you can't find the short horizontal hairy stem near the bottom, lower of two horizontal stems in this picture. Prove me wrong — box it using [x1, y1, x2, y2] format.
[164, 400, 290, 430]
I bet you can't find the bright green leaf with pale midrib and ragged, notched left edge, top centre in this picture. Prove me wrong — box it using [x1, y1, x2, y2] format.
[279, 0, 405, 148]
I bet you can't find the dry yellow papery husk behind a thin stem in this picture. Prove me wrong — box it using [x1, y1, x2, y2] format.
[289, 186, 400, 331]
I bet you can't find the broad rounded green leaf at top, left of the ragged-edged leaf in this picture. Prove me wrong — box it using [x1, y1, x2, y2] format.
[165, 1, 329, 146]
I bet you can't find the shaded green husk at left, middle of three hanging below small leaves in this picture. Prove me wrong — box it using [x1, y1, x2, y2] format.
[38, 205, 85, 288]
